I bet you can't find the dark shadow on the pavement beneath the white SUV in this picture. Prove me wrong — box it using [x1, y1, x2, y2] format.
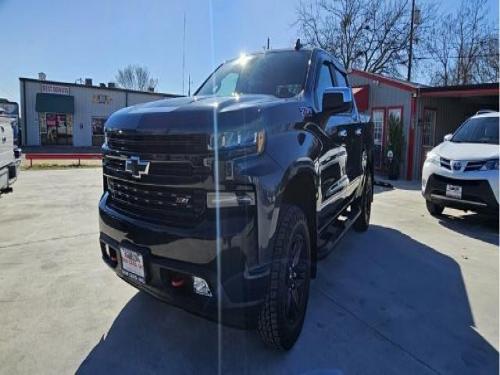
[438, 213, 498, 246]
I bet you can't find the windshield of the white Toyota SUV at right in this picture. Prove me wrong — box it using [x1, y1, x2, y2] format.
[451, 117, 498, 144]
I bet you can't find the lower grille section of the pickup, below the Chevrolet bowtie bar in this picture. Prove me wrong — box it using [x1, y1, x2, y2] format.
[107, 177, 206, 226]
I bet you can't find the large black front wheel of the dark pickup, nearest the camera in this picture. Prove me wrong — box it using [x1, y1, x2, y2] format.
[258, 205, 311, 350]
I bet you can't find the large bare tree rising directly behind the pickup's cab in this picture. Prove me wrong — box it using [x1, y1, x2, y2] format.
[296, 0, 431, 76]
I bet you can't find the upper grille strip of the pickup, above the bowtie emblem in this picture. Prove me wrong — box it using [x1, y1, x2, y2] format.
[108, 132, 208, 154]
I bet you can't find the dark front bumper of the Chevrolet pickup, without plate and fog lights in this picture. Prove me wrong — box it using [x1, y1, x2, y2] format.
[99, 193, 269, 326]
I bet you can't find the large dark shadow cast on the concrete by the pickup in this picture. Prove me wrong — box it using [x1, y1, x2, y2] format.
[78, 225, 498, 375]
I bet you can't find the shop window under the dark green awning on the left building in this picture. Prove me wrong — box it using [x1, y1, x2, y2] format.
[39, 112, 73, 145]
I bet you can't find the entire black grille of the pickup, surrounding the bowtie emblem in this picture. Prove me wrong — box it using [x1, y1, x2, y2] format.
[103, 132, 211, 226]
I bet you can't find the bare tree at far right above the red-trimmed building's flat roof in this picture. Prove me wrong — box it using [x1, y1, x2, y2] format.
[426, 0, 498, 85]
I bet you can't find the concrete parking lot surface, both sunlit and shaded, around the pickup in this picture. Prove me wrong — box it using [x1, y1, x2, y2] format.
[0, 168, 499, 374]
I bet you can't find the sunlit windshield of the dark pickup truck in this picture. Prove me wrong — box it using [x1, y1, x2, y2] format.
[196, 51, 311, 98]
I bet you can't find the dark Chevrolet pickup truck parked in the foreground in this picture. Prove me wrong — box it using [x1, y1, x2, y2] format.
[99, 45, 373, 349]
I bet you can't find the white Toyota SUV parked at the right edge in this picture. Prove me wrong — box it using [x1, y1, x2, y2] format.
[422, 112, 500, 215]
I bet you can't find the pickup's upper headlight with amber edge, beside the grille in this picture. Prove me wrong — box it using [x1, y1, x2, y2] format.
[208, 129, 266, 154]
